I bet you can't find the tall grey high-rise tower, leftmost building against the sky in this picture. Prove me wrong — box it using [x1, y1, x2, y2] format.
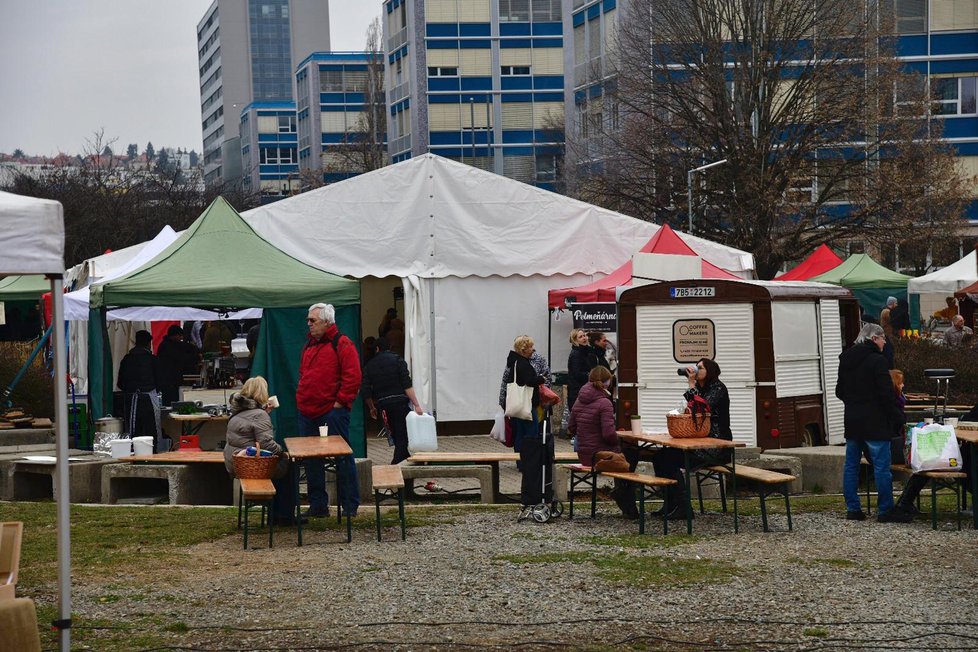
[197, 0, 329, 186]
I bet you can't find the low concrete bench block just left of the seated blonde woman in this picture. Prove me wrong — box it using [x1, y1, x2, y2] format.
[102, 463, 233, 505]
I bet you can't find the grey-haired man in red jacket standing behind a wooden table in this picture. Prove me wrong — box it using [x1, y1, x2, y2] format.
[295, 303, 361, 517]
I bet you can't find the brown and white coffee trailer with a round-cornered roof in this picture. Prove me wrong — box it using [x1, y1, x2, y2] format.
[617, 279, 860, 449]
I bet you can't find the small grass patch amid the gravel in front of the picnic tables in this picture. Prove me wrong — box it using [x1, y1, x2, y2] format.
[493, 552, 736, 588]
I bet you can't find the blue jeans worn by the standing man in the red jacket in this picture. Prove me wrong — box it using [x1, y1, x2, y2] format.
[299, 408, 360, 514]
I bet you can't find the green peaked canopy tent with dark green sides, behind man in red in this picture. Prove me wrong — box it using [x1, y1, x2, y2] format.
[89, 197, 366, 456]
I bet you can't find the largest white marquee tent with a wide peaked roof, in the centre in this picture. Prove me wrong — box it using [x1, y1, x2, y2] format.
[243, 154, 754, 421]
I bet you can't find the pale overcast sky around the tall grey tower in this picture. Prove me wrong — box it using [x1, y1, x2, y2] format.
[0, 0, 381, 155]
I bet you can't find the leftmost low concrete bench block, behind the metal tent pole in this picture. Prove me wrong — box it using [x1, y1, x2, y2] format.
[0, 455, 118, 503]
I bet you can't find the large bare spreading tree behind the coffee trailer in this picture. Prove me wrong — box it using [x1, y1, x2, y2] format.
[566, 0, 966, 278]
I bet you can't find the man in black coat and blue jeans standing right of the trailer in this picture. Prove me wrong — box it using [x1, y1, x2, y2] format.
[835, 324, 912, 523]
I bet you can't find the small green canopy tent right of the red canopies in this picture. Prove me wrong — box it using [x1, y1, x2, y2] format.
[809, 254, 920, 328]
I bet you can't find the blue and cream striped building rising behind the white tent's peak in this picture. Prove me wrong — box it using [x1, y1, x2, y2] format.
[382, 0, 565, 189]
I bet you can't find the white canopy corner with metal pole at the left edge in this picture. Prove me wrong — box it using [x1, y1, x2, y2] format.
[0, 187, 71, 651]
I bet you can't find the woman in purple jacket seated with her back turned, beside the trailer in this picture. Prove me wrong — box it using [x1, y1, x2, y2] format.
[567, 366, 638, 518]
